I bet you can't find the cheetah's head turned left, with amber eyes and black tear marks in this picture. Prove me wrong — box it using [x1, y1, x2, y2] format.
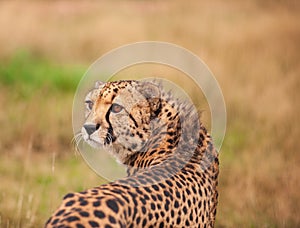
[81, 81, 160, 163]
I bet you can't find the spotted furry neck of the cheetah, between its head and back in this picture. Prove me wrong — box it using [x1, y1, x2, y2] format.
[120, 98, 212, 176]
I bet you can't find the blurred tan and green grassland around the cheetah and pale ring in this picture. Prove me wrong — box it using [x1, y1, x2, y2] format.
[0, 0, 300, 227]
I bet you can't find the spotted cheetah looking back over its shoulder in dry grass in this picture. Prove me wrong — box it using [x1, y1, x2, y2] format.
[45, 80, 219, 228]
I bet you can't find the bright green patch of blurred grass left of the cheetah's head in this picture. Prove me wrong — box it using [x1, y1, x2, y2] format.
[0, 51, 86, 97]
